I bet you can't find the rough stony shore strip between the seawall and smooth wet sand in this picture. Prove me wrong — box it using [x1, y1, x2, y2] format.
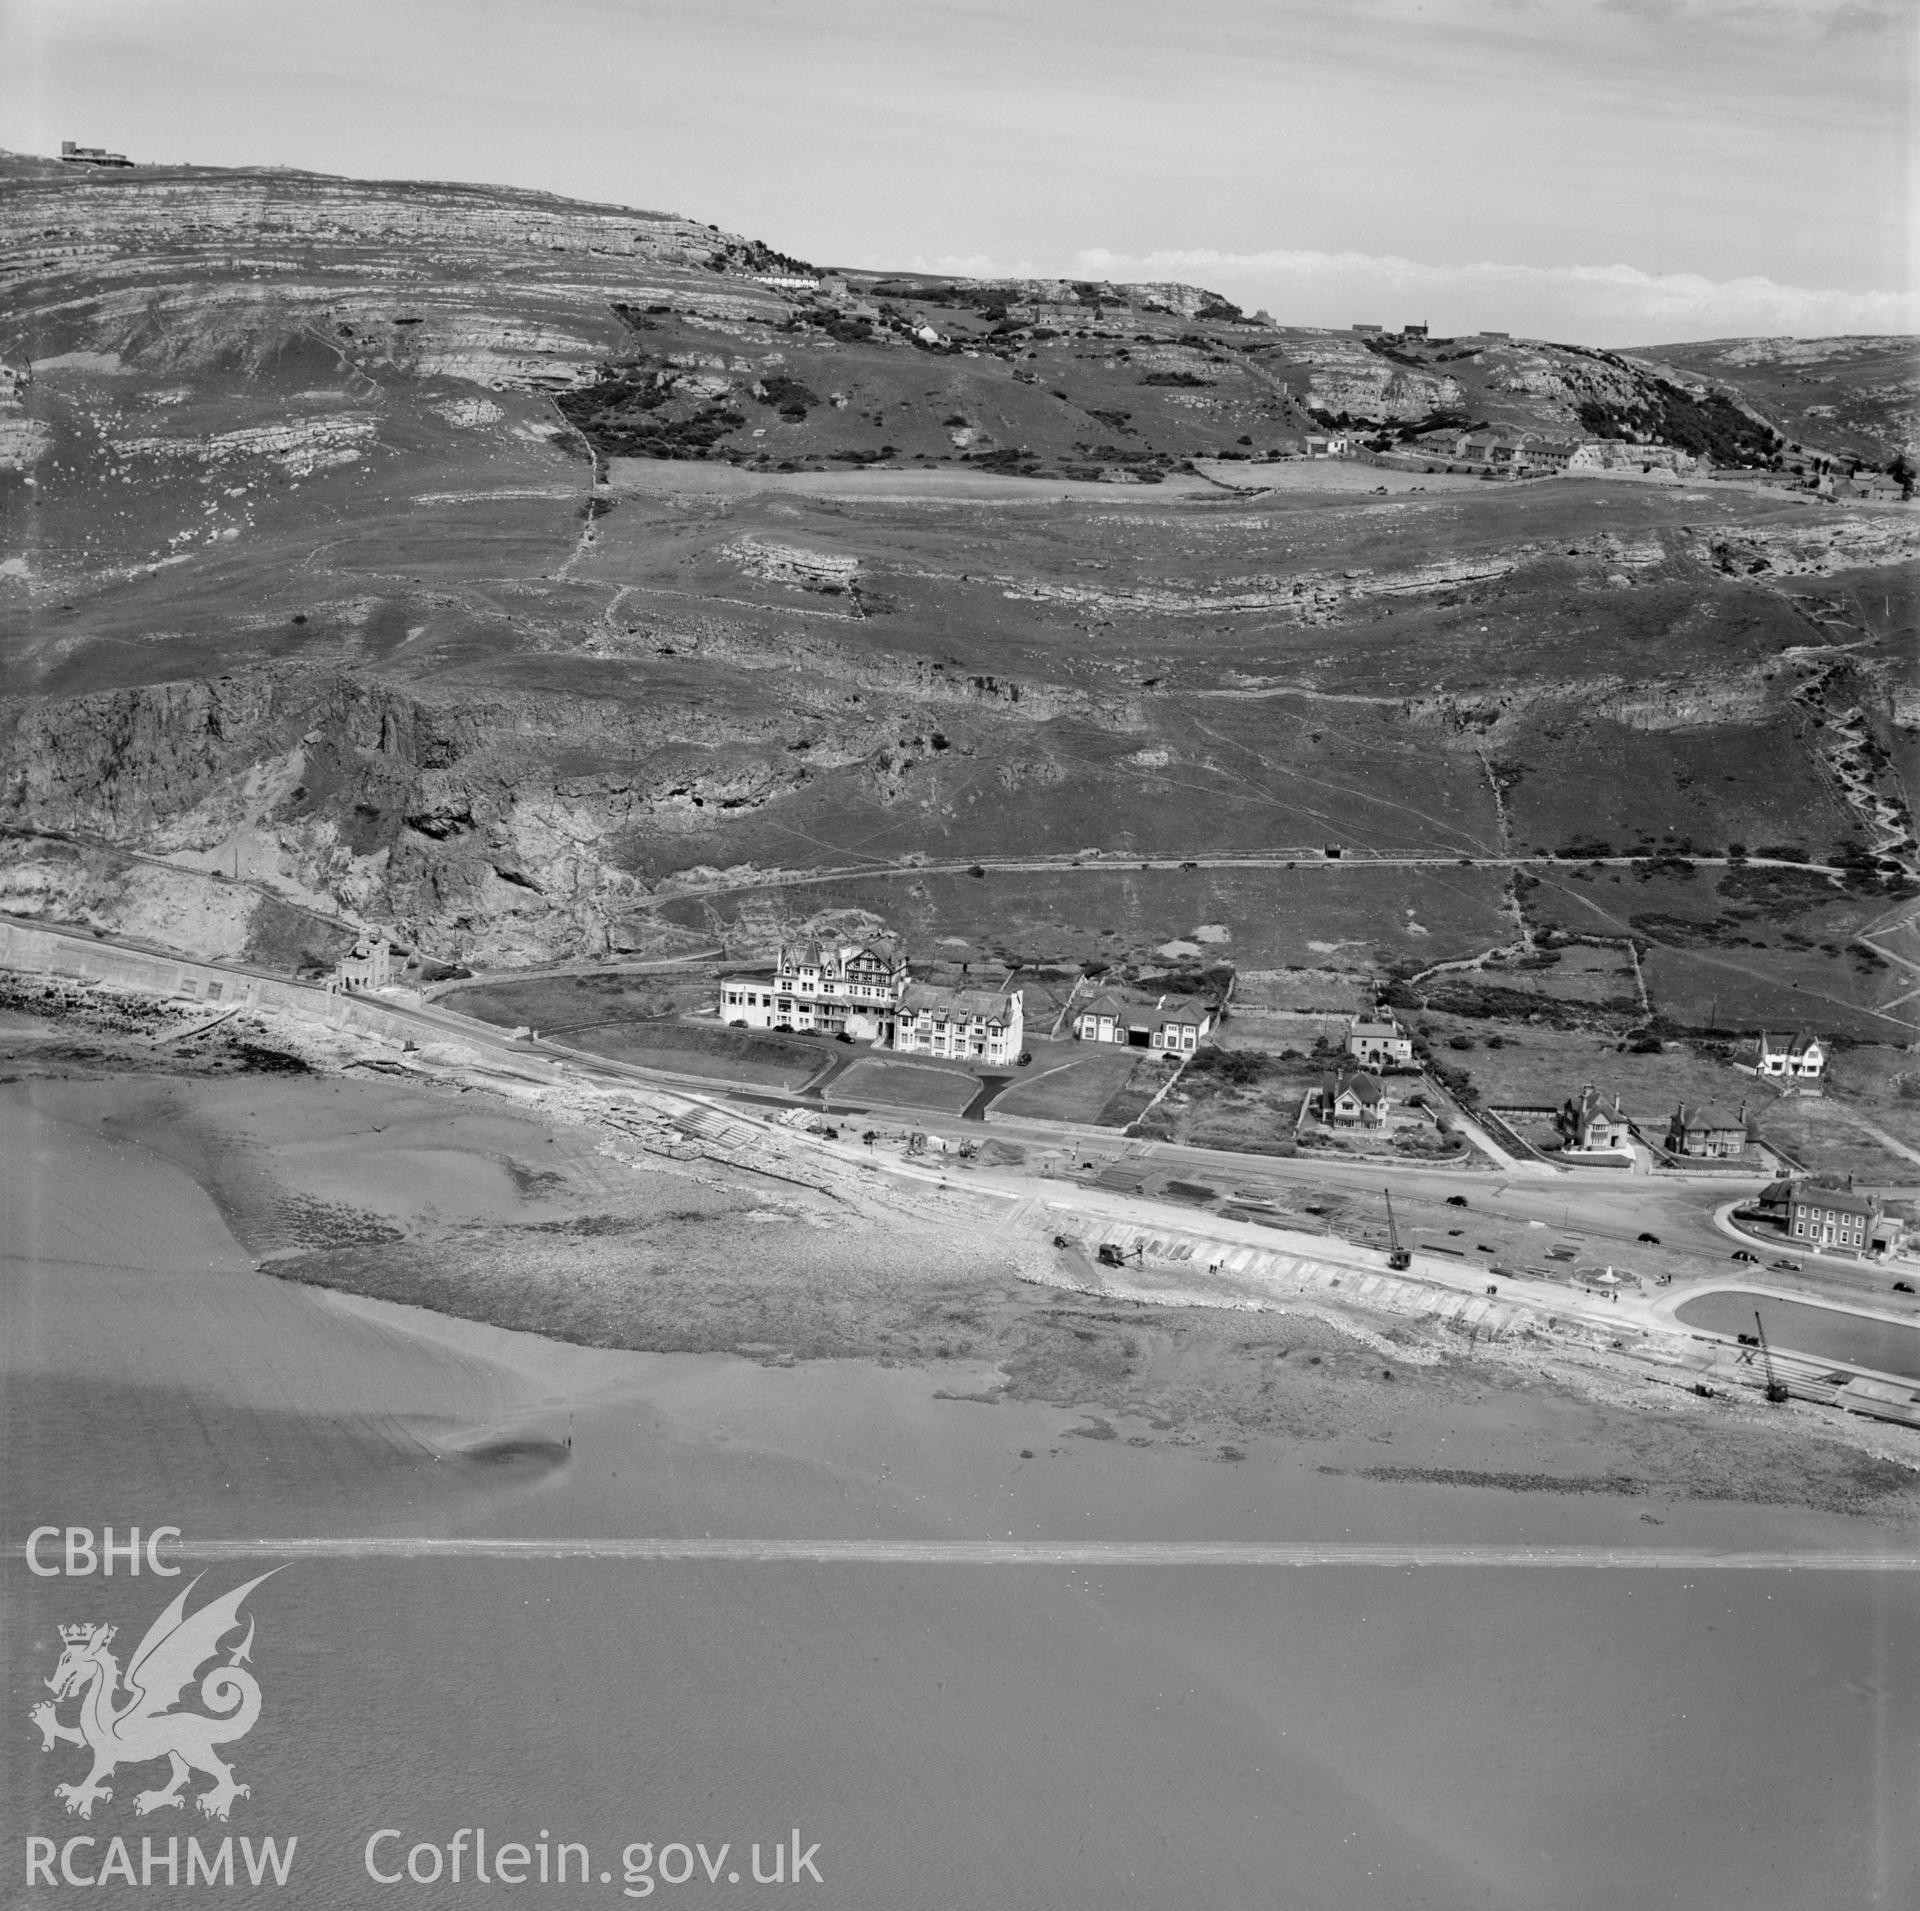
[12, 983, 1920, 1521]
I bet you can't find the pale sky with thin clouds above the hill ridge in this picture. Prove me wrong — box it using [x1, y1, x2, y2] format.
[0, 0, 1920, 346]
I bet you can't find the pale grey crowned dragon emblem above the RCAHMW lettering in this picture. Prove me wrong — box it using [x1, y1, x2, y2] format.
[29, 1567, 278, 1819]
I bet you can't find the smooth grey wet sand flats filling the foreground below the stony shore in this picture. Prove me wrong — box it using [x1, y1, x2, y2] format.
[0, 1083, 1920, 1911]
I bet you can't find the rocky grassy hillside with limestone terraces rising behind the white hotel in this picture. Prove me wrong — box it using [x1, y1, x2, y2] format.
[0, 159, 1920, 1044]
